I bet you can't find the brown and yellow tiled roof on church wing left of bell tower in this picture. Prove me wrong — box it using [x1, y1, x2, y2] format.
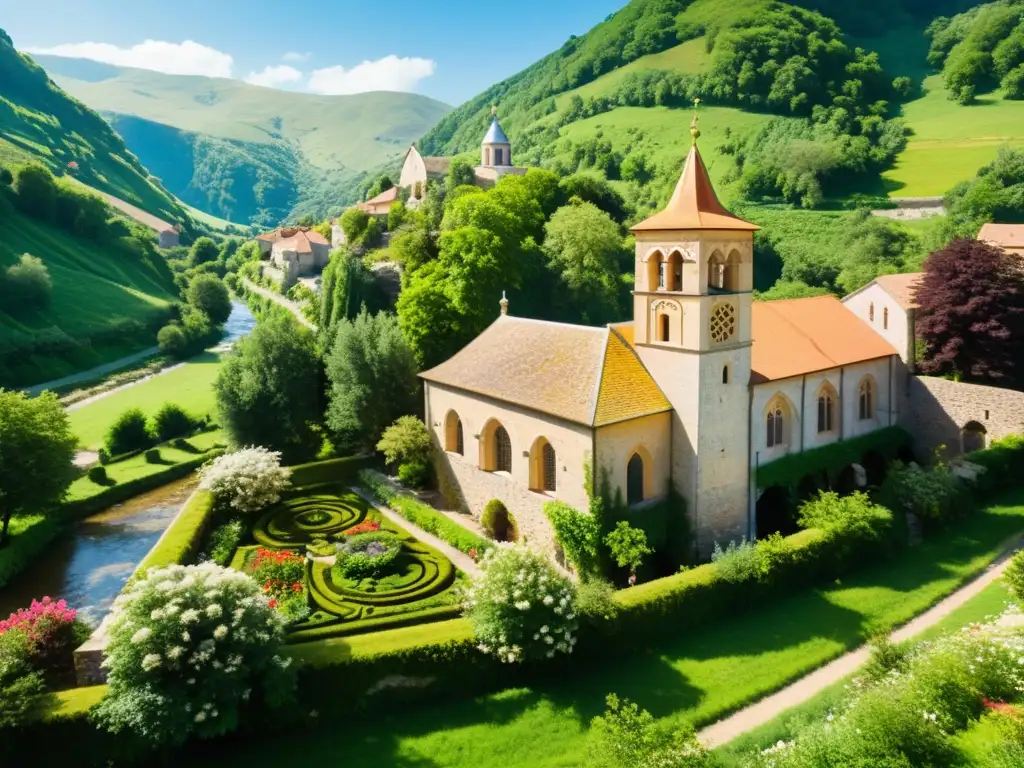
[420, 315, 670, 426]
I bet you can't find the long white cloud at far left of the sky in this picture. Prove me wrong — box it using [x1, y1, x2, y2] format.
[27, 40, 234, 78]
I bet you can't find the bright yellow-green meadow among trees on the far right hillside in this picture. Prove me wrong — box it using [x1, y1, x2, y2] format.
[884, 75, 1024, 198]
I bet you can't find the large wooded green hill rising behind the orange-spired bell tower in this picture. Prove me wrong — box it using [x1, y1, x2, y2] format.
[420, 0, 1024, 208]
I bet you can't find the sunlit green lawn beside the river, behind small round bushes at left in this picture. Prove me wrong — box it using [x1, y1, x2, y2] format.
[70, 352, 226, 451]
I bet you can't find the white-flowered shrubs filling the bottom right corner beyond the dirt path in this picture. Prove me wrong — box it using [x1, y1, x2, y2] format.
[748, 625, 1024, 768]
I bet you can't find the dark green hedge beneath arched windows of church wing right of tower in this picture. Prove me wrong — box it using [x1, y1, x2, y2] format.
[757, 427, 912, 488]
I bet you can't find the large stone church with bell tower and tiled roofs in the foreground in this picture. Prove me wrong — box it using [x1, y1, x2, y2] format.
[421, 118, 900, 557]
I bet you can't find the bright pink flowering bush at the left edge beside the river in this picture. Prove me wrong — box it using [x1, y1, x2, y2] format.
[0, 597, 90, 676]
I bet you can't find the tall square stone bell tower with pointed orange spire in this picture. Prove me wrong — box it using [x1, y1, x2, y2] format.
[633, 105, 759, 557]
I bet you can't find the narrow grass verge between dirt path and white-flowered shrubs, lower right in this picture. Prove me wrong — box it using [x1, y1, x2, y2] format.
[715, 582, 1010, 768]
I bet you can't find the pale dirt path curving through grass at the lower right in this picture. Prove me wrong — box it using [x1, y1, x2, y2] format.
[697, 536, 1024, 750]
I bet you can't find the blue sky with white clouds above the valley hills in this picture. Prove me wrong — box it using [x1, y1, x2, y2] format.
[0, 0, 627, 104]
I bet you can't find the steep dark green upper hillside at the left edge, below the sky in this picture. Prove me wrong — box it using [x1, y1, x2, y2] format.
[0, 30, 194, 234]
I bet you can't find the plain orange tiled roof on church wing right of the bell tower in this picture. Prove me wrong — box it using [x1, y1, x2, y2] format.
[751, 296, 897, 384]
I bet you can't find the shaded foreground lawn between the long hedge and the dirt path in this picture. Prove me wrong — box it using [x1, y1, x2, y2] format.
[193, 490, 1024, 768]
